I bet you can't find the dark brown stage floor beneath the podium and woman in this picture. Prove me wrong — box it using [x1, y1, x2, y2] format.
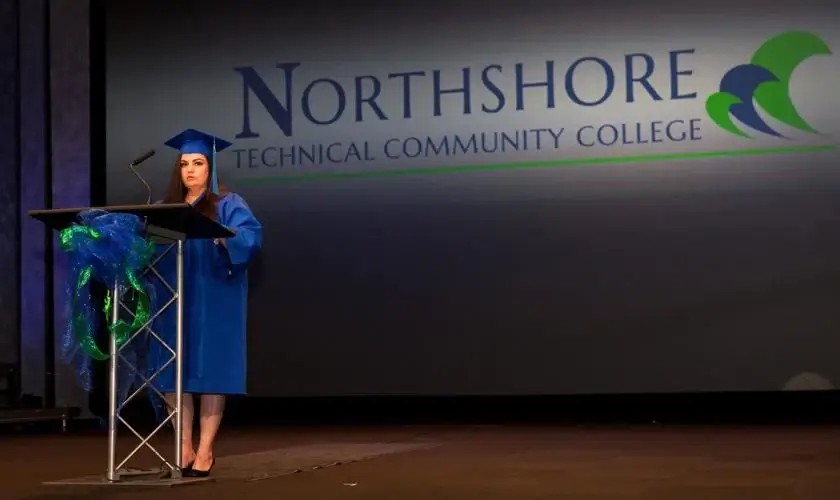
[0, 426, 840, 500]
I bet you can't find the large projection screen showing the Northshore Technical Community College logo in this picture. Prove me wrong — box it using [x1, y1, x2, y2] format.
[107, 0, 840, 396]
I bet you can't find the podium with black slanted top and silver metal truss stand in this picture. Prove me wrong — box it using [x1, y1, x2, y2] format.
[29, 203, 234, 486]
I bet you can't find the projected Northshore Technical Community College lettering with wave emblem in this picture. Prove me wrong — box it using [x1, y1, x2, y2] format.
[223, 25, 838, 182]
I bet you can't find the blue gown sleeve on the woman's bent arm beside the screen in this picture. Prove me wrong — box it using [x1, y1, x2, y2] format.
[215, 193, 262, 272]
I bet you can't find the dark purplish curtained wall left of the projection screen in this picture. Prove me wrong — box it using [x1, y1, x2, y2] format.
[0, 0, 95, 414]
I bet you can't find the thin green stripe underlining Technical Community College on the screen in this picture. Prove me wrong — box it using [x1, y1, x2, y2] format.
[236, 145, 836, 184]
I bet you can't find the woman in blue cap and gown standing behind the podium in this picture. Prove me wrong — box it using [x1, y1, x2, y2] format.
[149, 129, 262, 477]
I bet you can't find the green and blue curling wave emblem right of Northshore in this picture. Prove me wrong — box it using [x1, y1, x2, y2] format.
[706, 31, 831, 138]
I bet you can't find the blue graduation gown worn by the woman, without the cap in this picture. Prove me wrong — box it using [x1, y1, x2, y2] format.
[147, 193, 262, 395]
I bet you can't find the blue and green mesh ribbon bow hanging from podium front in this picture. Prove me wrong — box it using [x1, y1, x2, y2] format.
[59, 210, 155, 366]
